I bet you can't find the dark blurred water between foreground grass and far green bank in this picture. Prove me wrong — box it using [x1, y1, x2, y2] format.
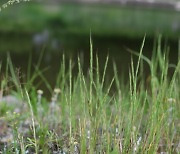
[0, 31, 178, 94]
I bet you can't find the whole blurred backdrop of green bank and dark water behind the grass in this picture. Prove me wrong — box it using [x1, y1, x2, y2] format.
[0, 0, 180, 88]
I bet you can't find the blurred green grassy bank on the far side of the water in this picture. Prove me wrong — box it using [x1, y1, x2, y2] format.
[0, 2, 180, 39]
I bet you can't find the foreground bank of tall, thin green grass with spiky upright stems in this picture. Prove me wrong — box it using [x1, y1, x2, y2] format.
[0, 37, 180, 154]
